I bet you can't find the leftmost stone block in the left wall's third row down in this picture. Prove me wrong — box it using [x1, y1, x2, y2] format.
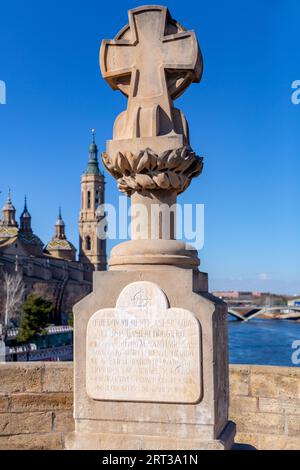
[0, 413, 52, 435]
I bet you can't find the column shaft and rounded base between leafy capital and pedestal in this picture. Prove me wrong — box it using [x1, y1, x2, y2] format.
[109, 190, 200, 271]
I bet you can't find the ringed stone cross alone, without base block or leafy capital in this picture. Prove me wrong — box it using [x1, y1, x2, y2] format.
[100, 5, 202, 138]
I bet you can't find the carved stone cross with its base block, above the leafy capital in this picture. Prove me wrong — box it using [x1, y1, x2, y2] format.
[100, 7, 202, 153]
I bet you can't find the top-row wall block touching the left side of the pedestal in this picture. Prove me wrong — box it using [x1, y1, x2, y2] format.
[43, 363, 73, 392]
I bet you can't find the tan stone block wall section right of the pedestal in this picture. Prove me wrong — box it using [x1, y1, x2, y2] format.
[230, 365, 300, 450]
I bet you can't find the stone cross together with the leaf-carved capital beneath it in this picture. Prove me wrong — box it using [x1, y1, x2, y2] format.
[100, 5, 203, 194]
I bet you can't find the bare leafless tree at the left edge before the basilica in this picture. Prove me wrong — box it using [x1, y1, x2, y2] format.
[3, 273, 25, 328]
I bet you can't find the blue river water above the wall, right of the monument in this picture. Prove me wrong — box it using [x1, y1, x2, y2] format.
[228, 318, 300, 367]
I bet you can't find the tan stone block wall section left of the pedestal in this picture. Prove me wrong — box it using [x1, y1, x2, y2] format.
[0, 362, 73, 449]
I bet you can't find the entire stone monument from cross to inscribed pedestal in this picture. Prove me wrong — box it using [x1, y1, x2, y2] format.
[68, 5, 235, 450]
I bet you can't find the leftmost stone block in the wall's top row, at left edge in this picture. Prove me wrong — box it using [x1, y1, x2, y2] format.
[0, 363, 42, 393]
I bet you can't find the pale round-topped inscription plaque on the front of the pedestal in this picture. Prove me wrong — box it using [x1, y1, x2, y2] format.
[86, 281, 201, 403]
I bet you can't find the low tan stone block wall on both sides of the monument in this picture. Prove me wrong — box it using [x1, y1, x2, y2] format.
[0, 362, 300, 449]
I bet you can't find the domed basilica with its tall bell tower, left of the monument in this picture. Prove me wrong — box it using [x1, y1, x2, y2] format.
[0, 132, 106, 324]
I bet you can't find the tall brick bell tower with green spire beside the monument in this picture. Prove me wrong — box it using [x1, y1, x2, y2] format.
[79, 129, 106, 280]
